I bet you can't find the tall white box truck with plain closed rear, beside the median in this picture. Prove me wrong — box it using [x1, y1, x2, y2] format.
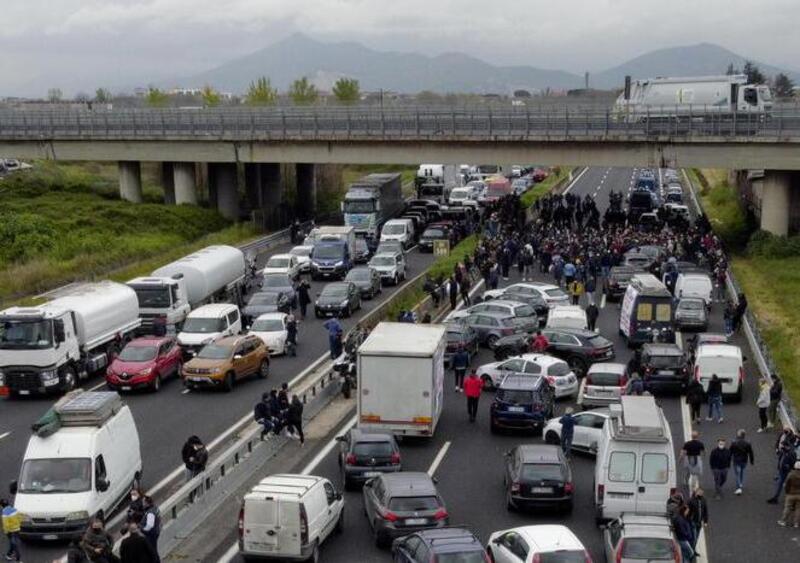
[357, 322, 446, 437]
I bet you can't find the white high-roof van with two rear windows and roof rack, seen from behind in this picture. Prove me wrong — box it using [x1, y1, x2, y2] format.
[594, 395, 676, 522]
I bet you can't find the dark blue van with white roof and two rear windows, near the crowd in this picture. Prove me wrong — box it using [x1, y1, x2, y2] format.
[620, 274, 675, 346]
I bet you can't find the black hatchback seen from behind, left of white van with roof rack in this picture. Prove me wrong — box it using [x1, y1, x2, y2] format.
[503, 444, 575, 512]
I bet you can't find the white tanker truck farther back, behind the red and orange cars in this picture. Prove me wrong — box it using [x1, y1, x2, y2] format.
[127, 245, 247, 334]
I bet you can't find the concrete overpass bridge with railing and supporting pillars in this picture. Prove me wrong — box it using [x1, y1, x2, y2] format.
[0, 106, 800, 234]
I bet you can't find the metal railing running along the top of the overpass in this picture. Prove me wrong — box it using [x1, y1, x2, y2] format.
[0, 105, 800, 142]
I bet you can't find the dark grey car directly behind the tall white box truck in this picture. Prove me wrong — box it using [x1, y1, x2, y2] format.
[336, 428, 403, 490]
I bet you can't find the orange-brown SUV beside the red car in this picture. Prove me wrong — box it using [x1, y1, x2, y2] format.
[181, 335, 269, 392]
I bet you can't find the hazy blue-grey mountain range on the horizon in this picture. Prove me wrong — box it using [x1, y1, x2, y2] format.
[179, 33, 800, 94]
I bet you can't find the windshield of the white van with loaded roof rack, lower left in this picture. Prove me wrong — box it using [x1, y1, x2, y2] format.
[19, 457, 92, 494]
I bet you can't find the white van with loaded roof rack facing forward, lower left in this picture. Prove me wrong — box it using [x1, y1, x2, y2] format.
[11, 390, 142, 540]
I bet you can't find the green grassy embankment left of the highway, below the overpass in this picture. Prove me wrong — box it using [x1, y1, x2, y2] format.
[0, 162, 255, 303]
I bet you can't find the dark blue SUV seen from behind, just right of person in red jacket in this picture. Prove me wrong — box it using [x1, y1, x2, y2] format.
[489, 375, 555, 433]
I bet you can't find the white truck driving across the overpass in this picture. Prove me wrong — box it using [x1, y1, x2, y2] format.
[614, 74, 772, 121]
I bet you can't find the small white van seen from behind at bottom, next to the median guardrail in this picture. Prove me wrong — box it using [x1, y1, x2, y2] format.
[239, 474, 344, 562]
